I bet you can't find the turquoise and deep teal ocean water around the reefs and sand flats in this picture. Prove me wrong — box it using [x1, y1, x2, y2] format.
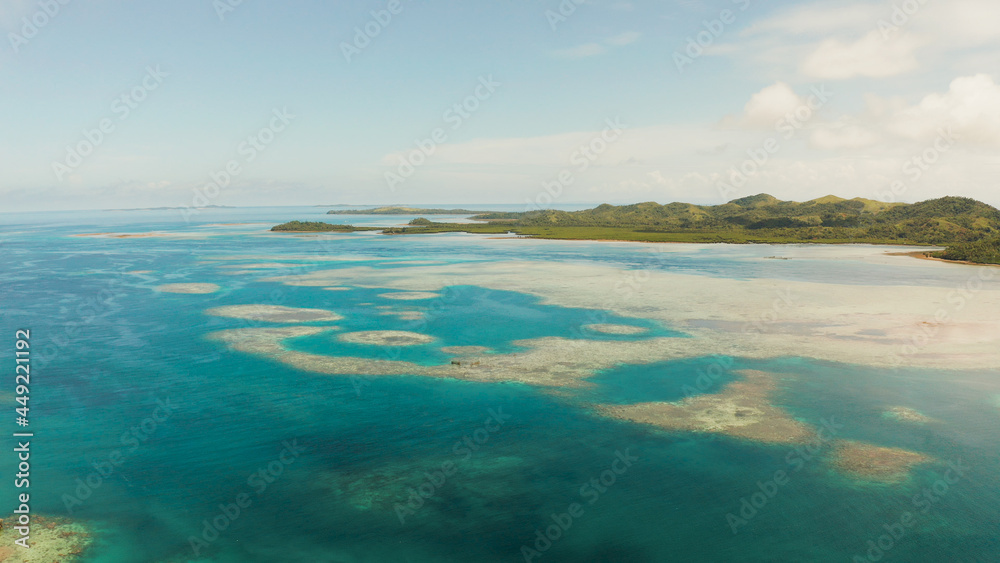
[0, 208, 1000, 563]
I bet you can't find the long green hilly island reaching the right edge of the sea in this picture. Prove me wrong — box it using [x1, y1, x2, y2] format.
[274, 194, 1000, 264]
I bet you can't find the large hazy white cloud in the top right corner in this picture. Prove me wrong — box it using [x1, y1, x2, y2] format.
[708, 0, 1000, 80]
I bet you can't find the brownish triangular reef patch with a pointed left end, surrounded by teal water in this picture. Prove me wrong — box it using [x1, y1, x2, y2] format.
[598, 371, 815, 444]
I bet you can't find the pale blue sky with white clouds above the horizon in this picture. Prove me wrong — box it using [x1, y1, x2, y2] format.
[0, 0, 1000, 211]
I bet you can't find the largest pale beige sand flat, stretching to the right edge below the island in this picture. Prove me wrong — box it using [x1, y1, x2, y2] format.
[266, 262, 1000, 369]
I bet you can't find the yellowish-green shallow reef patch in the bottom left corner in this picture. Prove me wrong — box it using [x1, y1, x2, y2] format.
[0, 516, 93, 563]
